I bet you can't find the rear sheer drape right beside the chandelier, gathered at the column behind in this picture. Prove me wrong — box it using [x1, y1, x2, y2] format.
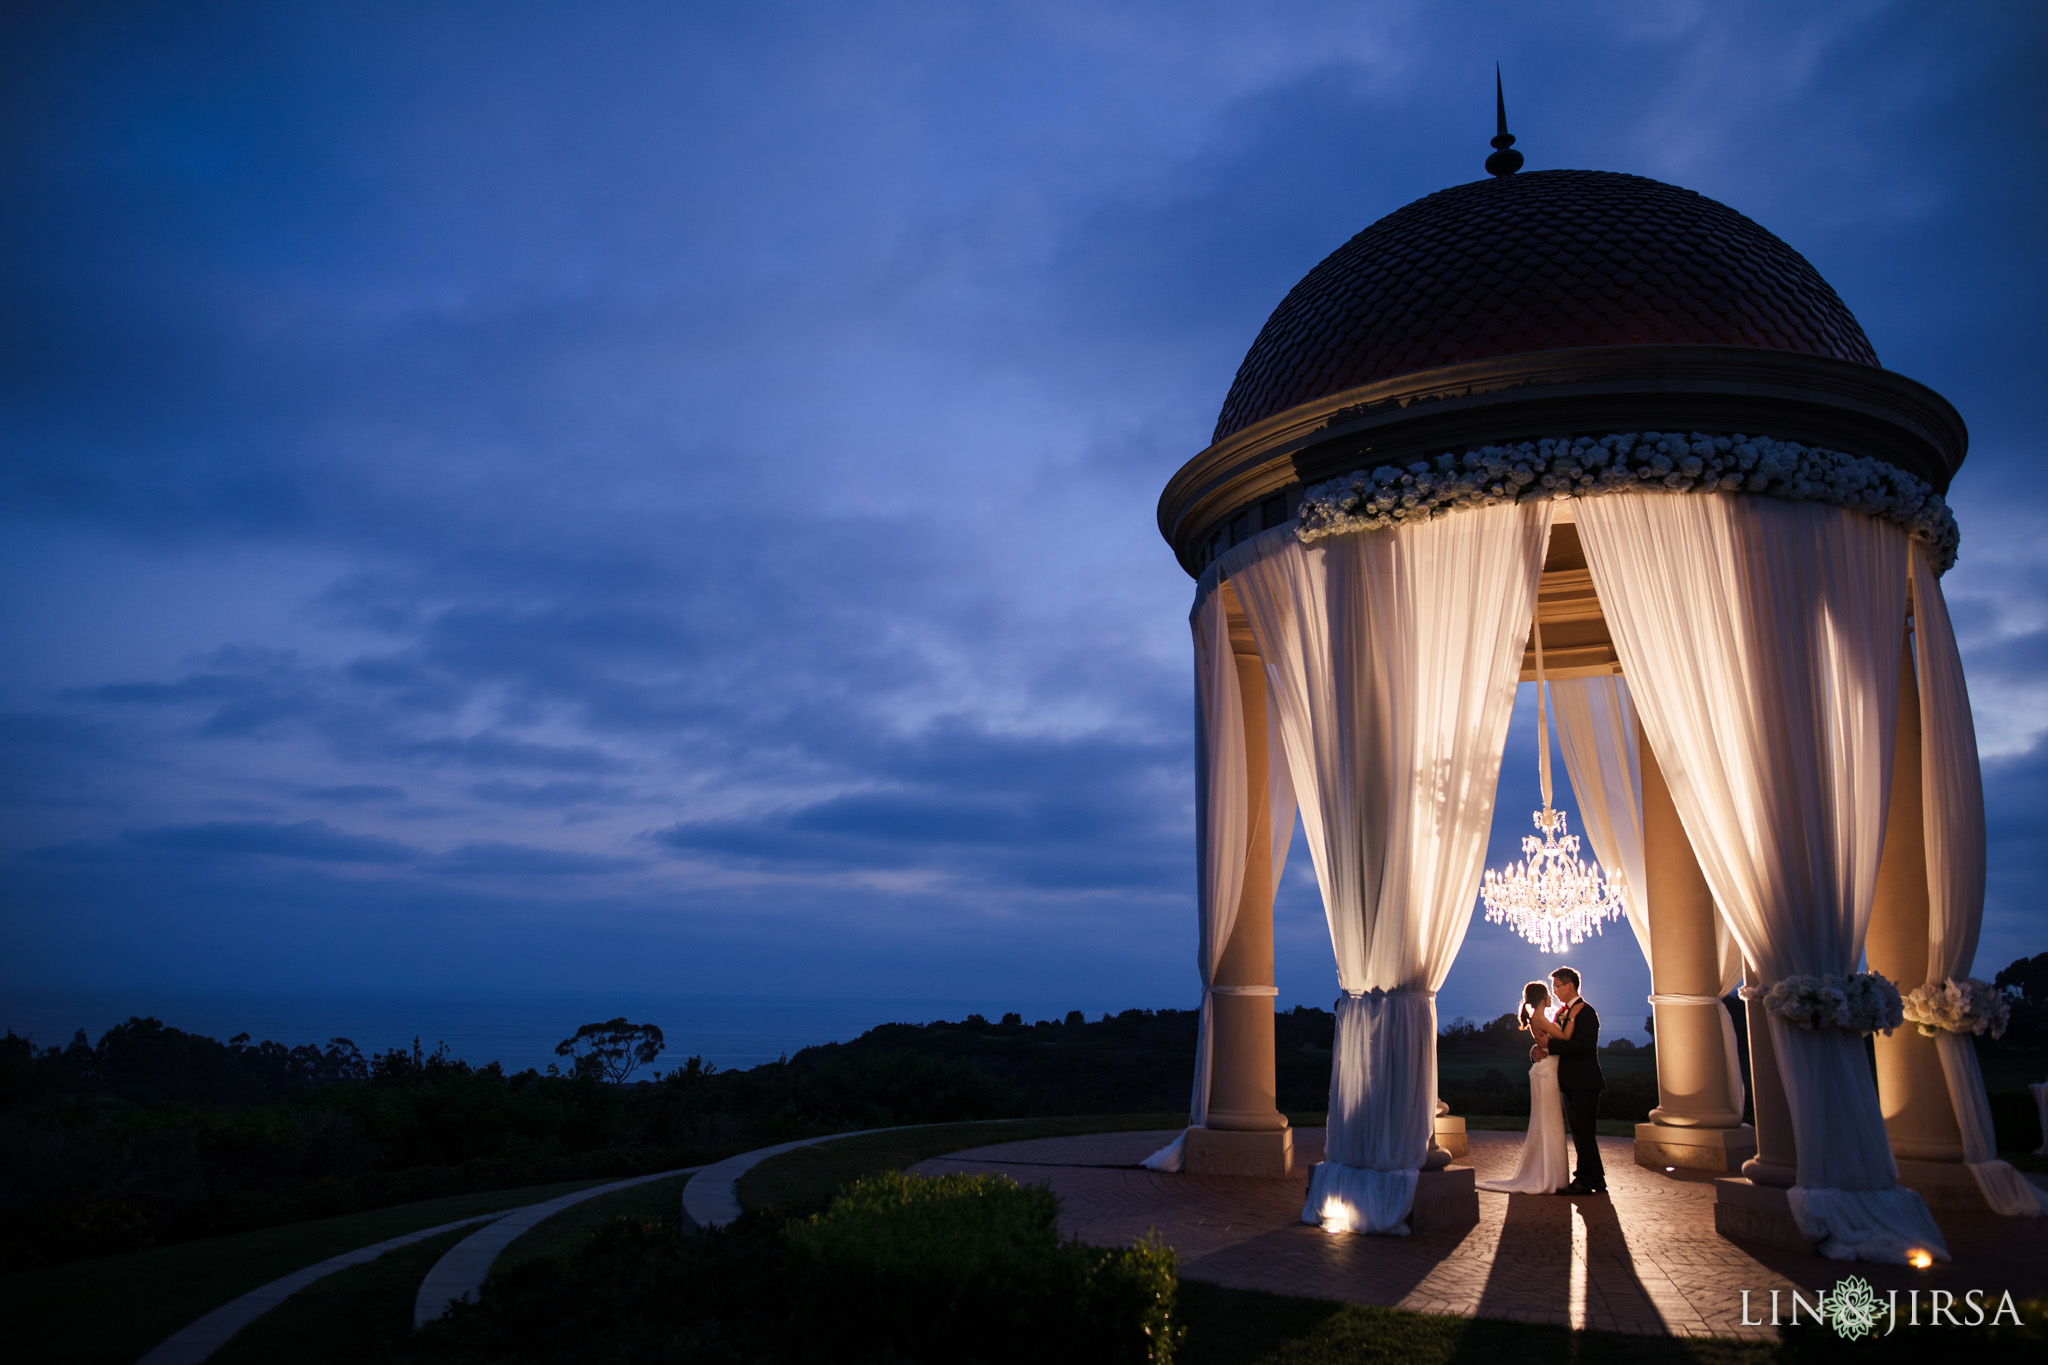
[1550, 675, 1745, 1113]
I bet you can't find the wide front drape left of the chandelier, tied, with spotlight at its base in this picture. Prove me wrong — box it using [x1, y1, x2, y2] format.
[1221, 503, 1550, 1232]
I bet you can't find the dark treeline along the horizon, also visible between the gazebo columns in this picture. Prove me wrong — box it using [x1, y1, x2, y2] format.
[0, 954, 2048, 1269]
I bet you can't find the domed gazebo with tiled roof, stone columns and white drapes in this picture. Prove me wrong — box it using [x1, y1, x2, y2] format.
[1151, 119, 2034, 1261]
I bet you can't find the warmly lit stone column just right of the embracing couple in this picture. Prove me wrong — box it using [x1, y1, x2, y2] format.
[1636, 724, 1757, 1175]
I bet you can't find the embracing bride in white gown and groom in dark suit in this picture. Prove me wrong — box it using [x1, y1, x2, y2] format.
[1479, 966, 1608, 1195]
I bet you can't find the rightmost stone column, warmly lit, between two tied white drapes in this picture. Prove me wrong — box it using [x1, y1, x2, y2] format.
[1864, 641, 1985, 1209]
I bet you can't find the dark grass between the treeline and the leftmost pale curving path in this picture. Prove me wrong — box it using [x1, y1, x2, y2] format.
[0, 1181, 608, 1365]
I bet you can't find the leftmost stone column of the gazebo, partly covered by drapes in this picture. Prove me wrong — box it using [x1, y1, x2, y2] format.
[1186, 583, 1294, 1177]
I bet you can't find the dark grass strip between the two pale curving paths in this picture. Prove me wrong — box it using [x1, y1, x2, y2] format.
[209, 1228, 475, 1365]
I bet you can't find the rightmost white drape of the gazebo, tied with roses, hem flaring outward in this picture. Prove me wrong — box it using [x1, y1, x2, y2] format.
[1898, 544, 2044, 1218]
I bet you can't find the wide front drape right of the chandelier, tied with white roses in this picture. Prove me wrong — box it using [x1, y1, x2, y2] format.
[1577, 493, 1948, 1263]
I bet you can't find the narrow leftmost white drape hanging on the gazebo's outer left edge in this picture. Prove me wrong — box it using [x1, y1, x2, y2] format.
[1145, 581, 1249, 1171]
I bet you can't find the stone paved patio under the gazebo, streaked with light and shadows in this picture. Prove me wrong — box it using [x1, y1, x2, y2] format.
[913, 1128, 2048, 1336]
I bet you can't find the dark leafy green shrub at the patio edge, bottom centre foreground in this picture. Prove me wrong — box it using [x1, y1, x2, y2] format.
[784, 1173, 1180, 1365]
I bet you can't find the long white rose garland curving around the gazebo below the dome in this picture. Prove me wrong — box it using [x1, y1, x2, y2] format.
[1294, 432, 1962, 573]
